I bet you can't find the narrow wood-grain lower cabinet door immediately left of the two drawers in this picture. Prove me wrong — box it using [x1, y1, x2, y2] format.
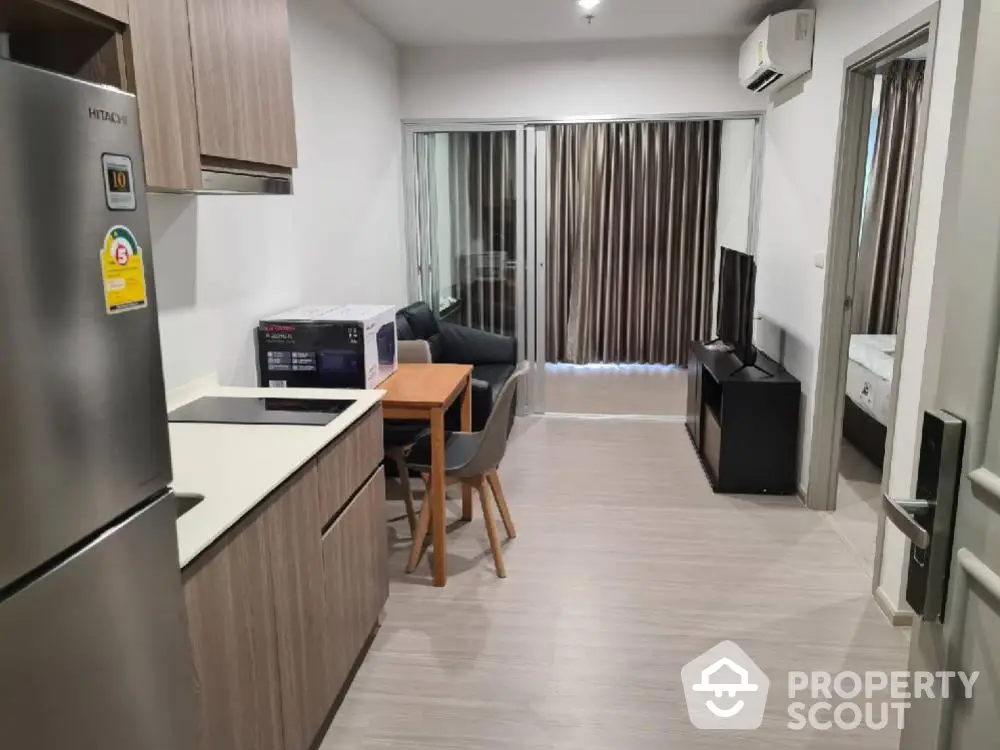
[265, 461, 332, 750]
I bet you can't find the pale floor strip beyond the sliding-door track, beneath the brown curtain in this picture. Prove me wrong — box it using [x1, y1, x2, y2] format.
[545, 363, 687, 417]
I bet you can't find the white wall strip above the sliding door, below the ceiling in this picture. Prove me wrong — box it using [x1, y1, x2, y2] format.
[400, 39, 766, 119]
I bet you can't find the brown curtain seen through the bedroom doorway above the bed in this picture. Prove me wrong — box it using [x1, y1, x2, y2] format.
[855, 60, 925, 334]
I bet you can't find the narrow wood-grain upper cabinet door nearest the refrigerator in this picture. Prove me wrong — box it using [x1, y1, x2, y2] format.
[124, 0, 201, 190]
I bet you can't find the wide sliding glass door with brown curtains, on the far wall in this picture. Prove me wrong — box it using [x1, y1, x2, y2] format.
[404, 116, 762, 416]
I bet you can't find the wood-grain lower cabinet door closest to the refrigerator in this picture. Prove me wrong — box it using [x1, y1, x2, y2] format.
[184, 518, 284, 750]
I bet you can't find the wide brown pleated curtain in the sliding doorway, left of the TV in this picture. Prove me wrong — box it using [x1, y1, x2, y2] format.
[546, 121, 722, 364]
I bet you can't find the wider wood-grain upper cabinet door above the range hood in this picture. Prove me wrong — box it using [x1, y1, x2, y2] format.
[187, 0, 298, 168]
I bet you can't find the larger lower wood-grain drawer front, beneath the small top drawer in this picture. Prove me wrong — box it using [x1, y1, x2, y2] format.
[323, 469, 389, 703]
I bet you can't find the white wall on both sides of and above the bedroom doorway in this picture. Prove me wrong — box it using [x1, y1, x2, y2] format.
[757, 0, 962, 603]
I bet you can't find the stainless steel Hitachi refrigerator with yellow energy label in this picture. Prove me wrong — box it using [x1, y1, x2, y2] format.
[0, 60, 196, 750]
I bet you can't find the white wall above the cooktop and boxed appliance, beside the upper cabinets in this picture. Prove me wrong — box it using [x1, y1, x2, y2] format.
[149, 0, 406, 388]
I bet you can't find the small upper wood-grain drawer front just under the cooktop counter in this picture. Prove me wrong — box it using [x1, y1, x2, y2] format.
[319, 406, 383, 526]
